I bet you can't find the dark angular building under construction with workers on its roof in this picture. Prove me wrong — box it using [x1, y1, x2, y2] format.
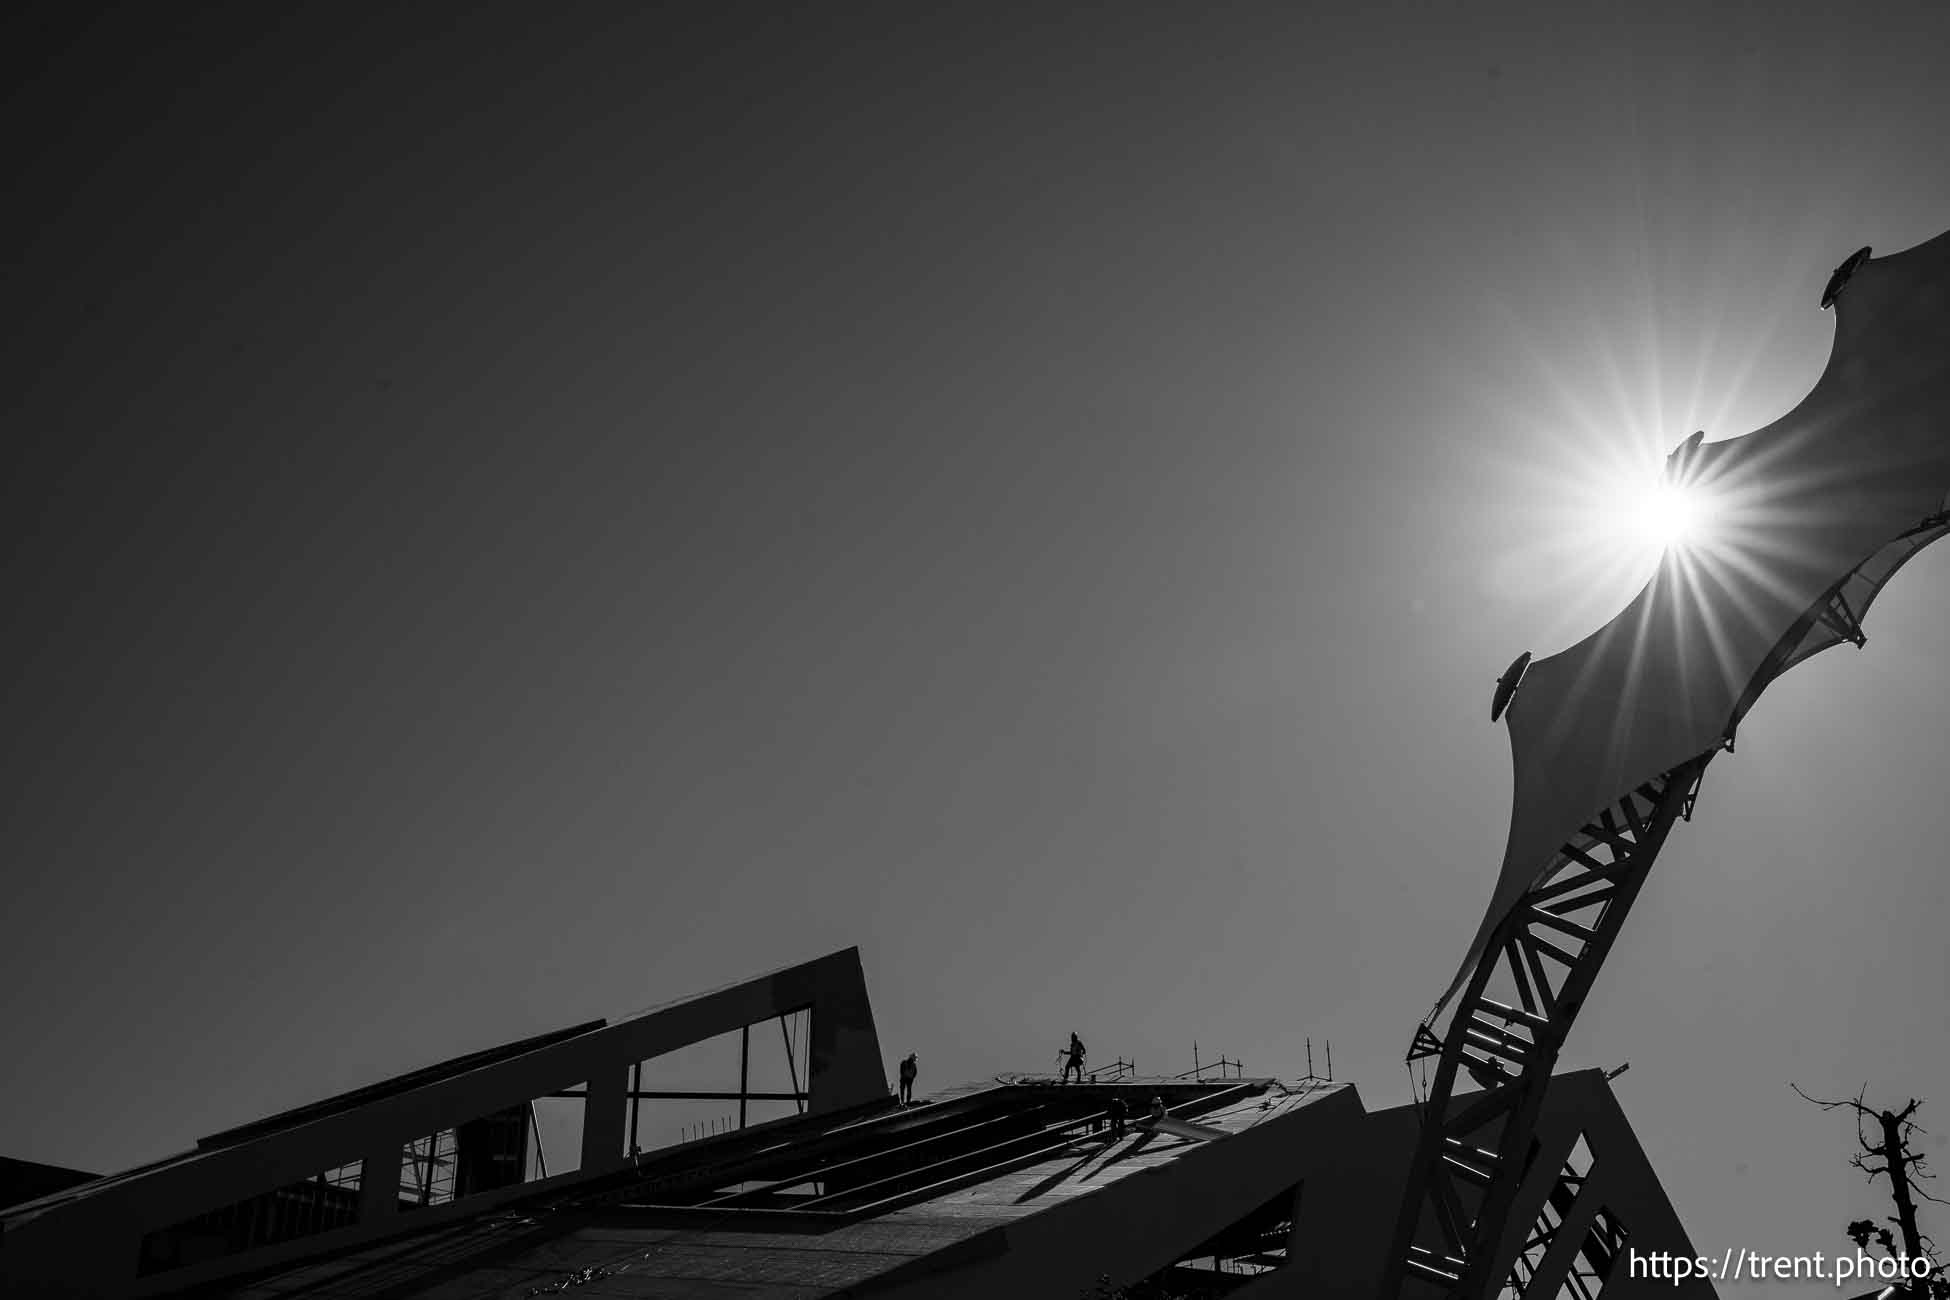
[0, 949, 1712, 1300]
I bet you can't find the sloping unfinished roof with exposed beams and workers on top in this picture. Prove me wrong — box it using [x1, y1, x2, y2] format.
[230, 1078, 1333, 1300]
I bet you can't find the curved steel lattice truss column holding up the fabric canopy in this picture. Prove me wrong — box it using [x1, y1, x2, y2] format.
[1381, 754, 1712, 1300]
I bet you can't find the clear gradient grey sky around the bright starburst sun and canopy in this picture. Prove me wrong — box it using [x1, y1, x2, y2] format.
[0, 4, 1950, 1296]
